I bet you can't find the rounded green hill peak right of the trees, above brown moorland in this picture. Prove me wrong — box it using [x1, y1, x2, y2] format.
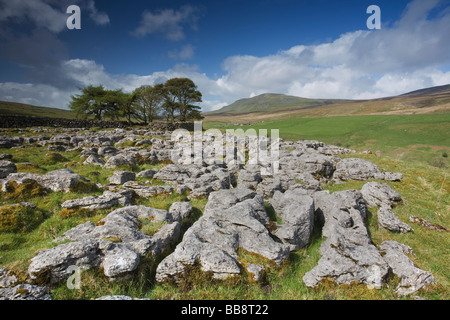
[207, 93, 350, 115]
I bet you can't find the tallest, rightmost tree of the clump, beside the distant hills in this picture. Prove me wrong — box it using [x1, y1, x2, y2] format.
[164, 78, 202, 122]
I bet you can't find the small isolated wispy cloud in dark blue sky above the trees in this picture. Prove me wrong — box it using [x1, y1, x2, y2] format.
[132, 5, 199, 41]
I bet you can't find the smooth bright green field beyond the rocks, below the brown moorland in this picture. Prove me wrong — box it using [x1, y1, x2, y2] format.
[203, 113, 450, 167]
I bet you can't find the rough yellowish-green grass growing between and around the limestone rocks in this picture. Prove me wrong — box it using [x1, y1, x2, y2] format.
[0, 120, 450, 300]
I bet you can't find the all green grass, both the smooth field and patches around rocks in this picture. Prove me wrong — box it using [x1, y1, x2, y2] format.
[0, 114, 450, 300]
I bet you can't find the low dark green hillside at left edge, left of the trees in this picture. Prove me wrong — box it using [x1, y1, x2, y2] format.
[0, 101, 76, 119]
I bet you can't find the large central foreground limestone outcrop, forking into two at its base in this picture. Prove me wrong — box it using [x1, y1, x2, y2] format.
[156, 189, 289, 282]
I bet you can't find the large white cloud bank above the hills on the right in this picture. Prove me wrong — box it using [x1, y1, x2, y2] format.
[212, 0, 450, 99]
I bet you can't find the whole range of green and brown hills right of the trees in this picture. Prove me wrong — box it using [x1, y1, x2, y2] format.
[203, 84, 450, 122]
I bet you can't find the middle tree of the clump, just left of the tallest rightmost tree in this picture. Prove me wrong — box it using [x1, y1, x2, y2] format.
[133, 84, 164, 124]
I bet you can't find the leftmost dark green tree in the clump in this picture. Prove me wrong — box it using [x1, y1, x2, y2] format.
[69, 85, 107, 120]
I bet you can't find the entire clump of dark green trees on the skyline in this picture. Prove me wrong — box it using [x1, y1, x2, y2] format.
[70, 78, 203, 124]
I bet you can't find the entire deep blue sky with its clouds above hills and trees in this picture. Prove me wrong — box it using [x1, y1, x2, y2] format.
[0, 0, 450, 111]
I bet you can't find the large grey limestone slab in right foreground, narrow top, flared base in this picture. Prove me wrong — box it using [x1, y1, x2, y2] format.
[303, 190, 389, 288]
